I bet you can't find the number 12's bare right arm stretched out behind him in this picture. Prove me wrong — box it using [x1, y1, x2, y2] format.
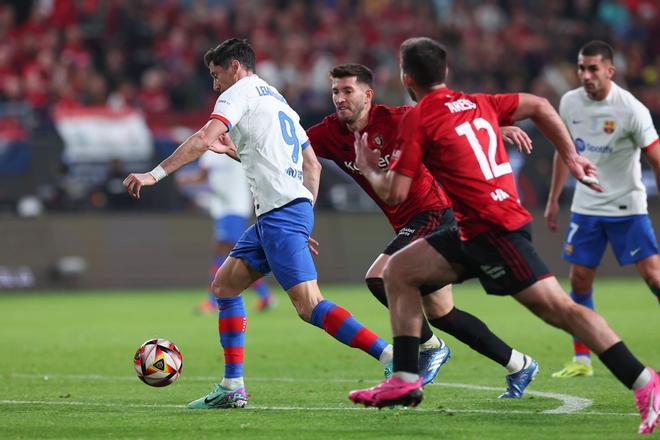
[513, 93, 603, 192]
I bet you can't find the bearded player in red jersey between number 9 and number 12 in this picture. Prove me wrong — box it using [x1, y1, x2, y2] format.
[307, 64, 530, 398]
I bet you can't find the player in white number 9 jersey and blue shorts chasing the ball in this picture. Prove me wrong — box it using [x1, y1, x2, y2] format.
[124, 38, 392, 409]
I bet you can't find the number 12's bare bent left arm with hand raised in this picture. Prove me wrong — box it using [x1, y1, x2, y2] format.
[354, 133, 412, 205]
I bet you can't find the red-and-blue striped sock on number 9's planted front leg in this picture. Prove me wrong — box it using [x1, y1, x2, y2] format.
[218, 296, 247, 379]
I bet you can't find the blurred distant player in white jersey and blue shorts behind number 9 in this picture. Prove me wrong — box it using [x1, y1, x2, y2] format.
[176, 151, 274, 313]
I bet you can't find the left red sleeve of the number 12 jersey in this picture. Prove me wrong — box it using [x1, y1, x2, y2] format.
[389, 108, 423, 177]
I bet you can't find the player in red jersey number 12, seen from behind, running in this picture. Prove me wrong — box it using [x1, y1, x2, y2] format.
[349, 38, 660, 433]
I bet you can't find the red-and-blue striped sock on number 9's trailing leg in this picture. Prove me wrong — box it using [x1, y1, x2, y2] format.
[310, 299, 387, 359]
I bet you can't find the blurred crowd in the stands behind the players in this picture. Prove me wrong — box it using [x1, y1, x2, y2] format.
[0, 0, 660, 215]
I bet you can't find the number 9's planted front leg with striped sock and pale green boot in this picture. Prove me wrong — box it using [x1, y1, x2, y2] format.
[188, 257, 262, 409]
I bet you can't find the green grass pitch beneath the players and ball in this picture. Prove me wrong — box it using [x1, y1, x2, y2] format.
[0, 279, 660, 440]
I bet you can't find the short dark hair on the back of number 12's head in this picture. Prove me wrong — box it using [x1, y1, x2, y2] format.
[399, 37, 447, 87]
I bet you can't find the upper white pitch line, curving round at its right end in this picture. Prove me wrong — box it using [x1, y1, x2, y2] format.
[10, 373, 593, 414]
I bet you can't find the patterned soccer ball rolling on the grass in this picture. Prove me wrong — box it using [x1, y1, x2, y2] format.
[133, 338, 183, 387]
